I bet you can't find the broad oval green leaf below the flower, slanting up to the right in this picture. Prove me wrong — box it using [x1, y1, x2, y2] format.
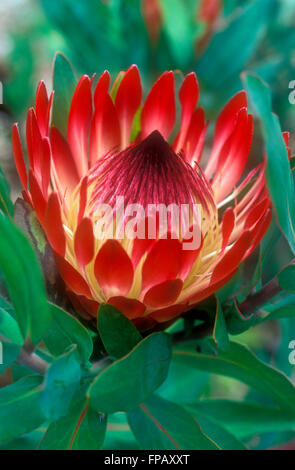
[88, 333, 171, 413]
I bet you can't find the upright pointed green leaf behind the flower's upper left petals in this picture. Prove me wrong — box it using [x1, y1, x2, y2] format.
[52, 52, 77, 136]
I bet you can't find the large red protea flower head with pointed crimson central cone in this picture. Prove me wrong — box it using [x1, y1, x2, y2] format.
[12, 66, 271, 327]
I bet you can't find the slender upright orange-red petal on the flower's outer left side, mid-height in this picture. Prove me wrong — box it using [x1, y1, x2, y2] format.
[45, 193, 66, 256]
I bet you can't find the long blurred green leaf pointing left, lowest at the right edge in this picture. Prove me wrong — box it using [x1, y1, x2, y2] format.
[189, 400, 295, 439]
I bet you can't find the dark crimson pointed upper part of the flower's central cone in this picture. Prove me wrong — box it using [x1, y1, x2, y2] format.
[90, 131, 215, 214]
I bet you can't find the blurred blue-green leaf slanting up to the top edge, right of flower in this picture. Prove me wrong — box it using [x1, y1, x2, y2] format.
[197, 0, 274, 89]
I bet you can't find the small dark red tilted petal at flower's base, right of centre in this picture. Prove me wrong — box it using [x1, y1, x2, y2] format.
[143, 279, 183, 308]
